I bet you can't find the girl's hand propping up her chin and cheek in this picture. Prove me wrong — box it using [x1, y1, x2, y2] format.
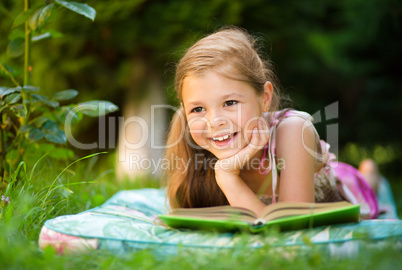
[215, 117, 270, 176]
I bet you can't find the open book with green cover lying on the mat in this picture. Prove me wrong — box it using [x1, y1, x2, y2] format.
[159, 201, 360, 233]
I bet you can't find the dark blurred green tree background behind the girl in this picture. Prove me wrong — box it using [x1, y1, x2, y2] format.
[0, 0, 402, 188]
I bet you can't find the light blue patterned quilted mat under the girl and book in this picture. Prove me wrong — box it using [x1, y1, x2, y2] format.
[39, 179, 402, 255]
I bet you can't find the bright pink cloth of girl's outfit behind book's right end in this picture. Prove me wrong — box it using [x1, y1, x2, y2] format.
[331, 162, 379, 219]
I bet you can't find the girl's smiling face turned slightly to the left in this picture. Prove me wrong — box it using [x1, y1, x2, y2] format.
[182, 71, 272, 159]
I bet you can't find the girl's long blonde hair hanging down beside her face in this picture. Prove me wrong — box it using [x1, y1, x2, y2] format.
[165, 27, 280, 208]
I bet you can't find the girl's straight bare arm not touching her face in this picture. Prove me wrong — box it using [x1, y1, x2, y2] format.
[276, 117, 317, 202]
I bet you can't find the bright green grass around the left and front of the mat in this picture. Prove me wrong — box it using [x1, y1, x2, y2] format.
[0, 153, 402, 270]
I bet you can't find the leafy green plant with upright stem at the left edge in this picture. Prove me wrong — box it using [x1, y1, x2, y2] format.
[0, 0, 118, 194]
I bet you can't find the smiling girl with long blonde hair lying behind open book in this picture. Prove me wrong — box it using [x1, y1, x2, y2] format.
[166, 28, 378, 218]
